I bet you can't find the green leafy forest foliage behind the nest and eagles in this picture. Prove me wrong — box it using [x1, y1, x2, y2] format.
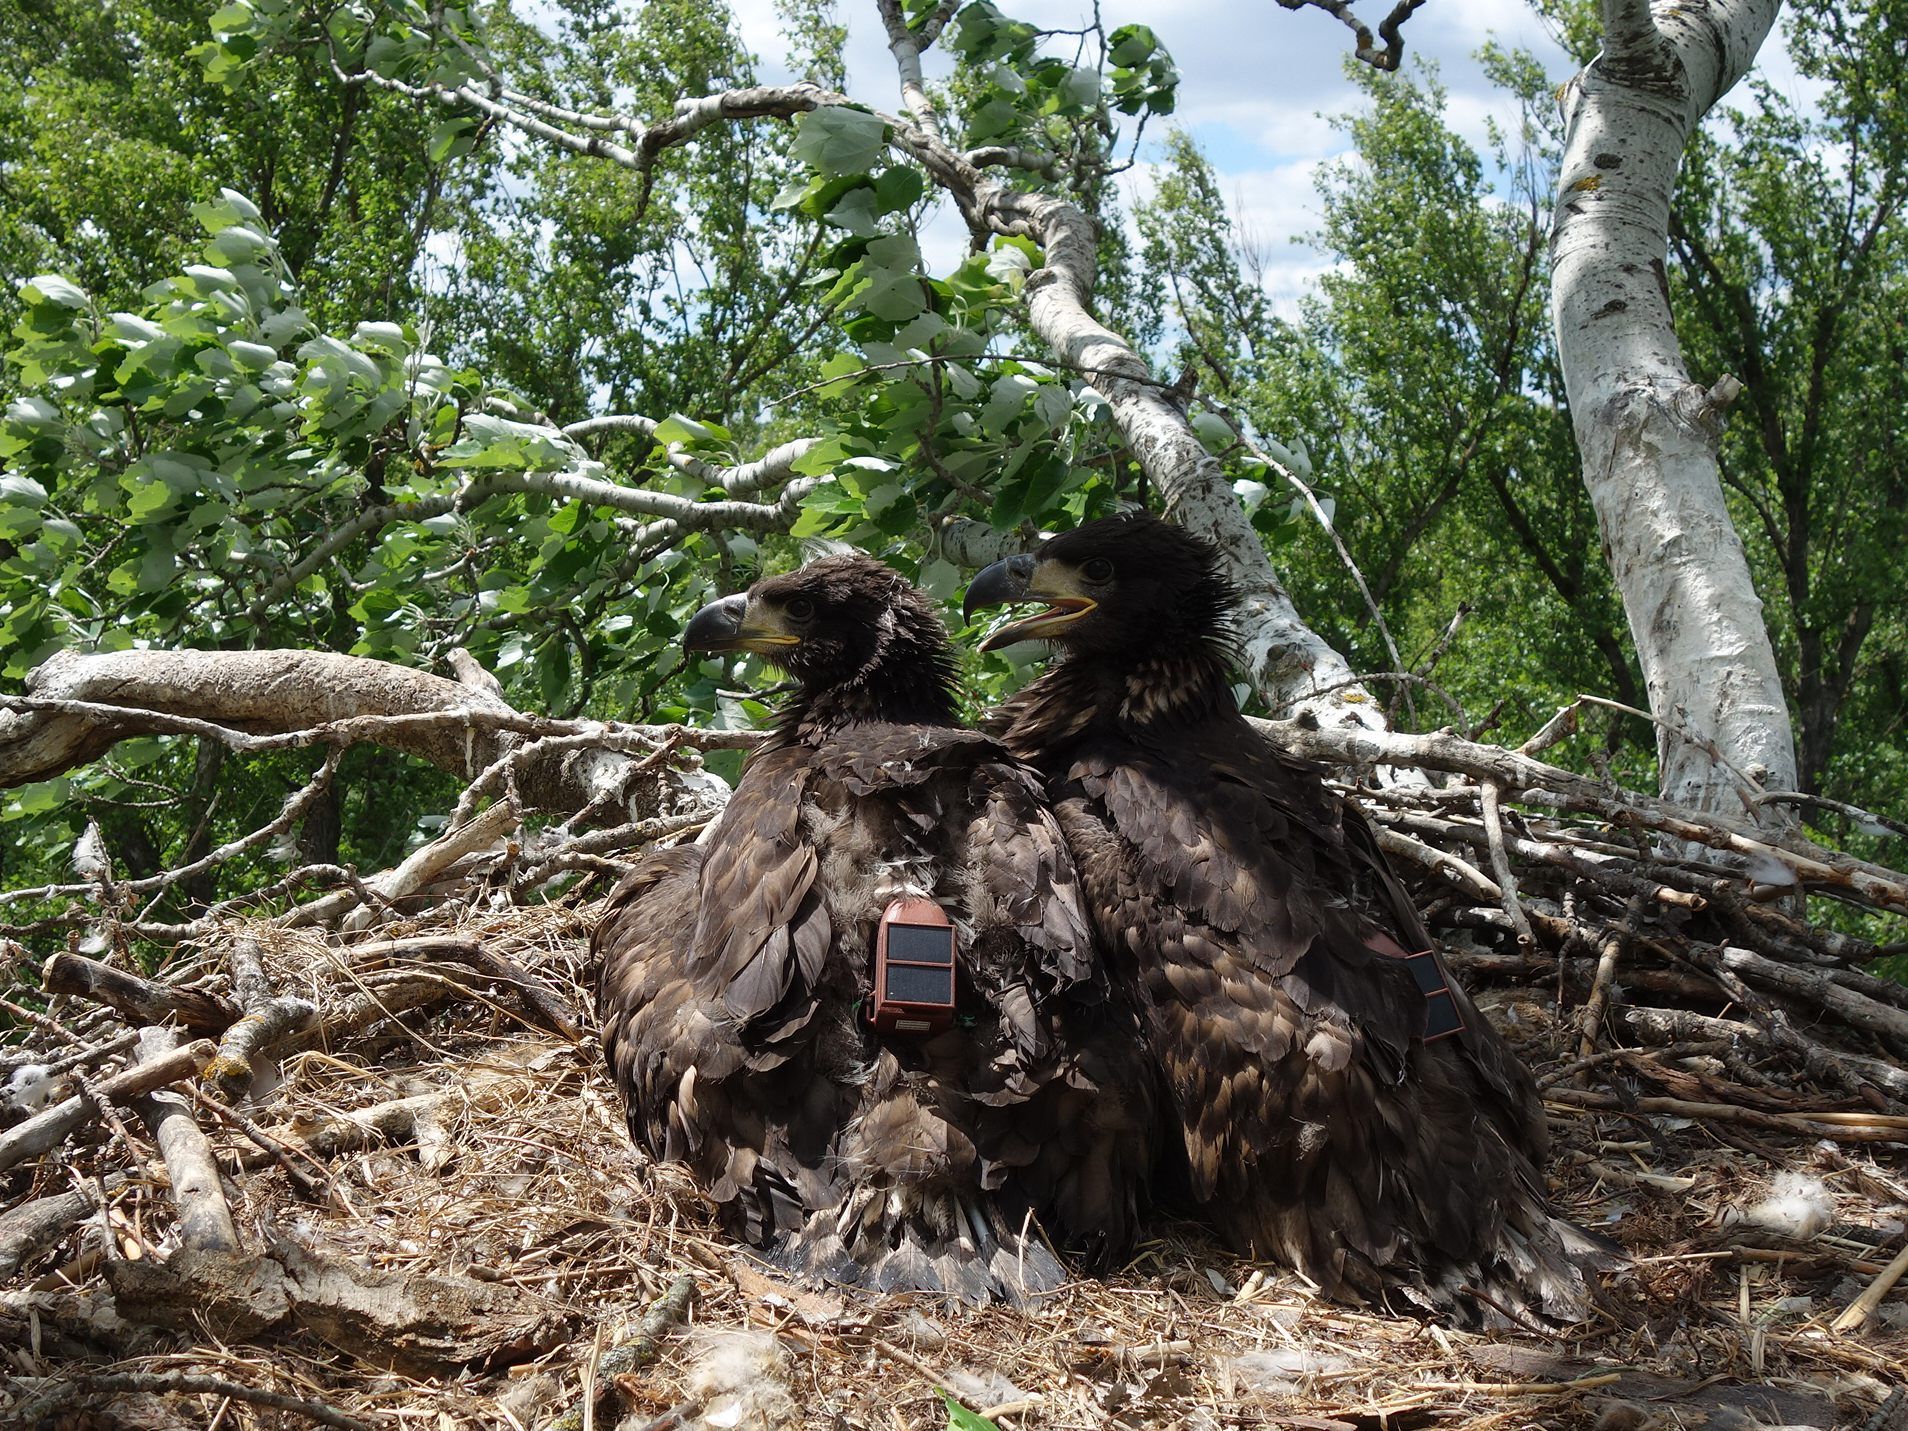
[0, 0, 1908, 946]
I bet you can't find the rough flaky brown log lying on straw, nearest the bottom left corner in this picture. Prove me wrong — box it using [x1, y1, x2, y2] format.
[107, 1238, 569, 1376]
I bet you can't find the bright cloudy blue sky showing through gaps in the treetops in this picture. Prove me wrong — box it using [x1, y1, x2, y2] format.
[735, 0, 1795, 313]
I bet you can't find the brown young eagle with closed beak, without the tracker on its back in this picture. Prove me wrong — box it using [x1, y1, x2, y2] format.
[595, 555, 1156, 1301]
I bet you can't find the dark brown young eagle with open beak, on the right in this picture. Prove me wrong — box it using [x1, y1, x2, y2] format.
[969, 515, 1597, 1320]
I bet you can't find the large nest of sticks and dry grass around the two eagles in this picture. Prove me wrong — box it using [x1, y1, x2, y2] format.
[0, 690, 1908, 1431]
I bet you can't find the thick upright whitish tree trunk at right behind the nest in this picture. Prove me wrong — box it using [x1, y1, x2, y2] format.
[1551, 0, 1795, 813]
